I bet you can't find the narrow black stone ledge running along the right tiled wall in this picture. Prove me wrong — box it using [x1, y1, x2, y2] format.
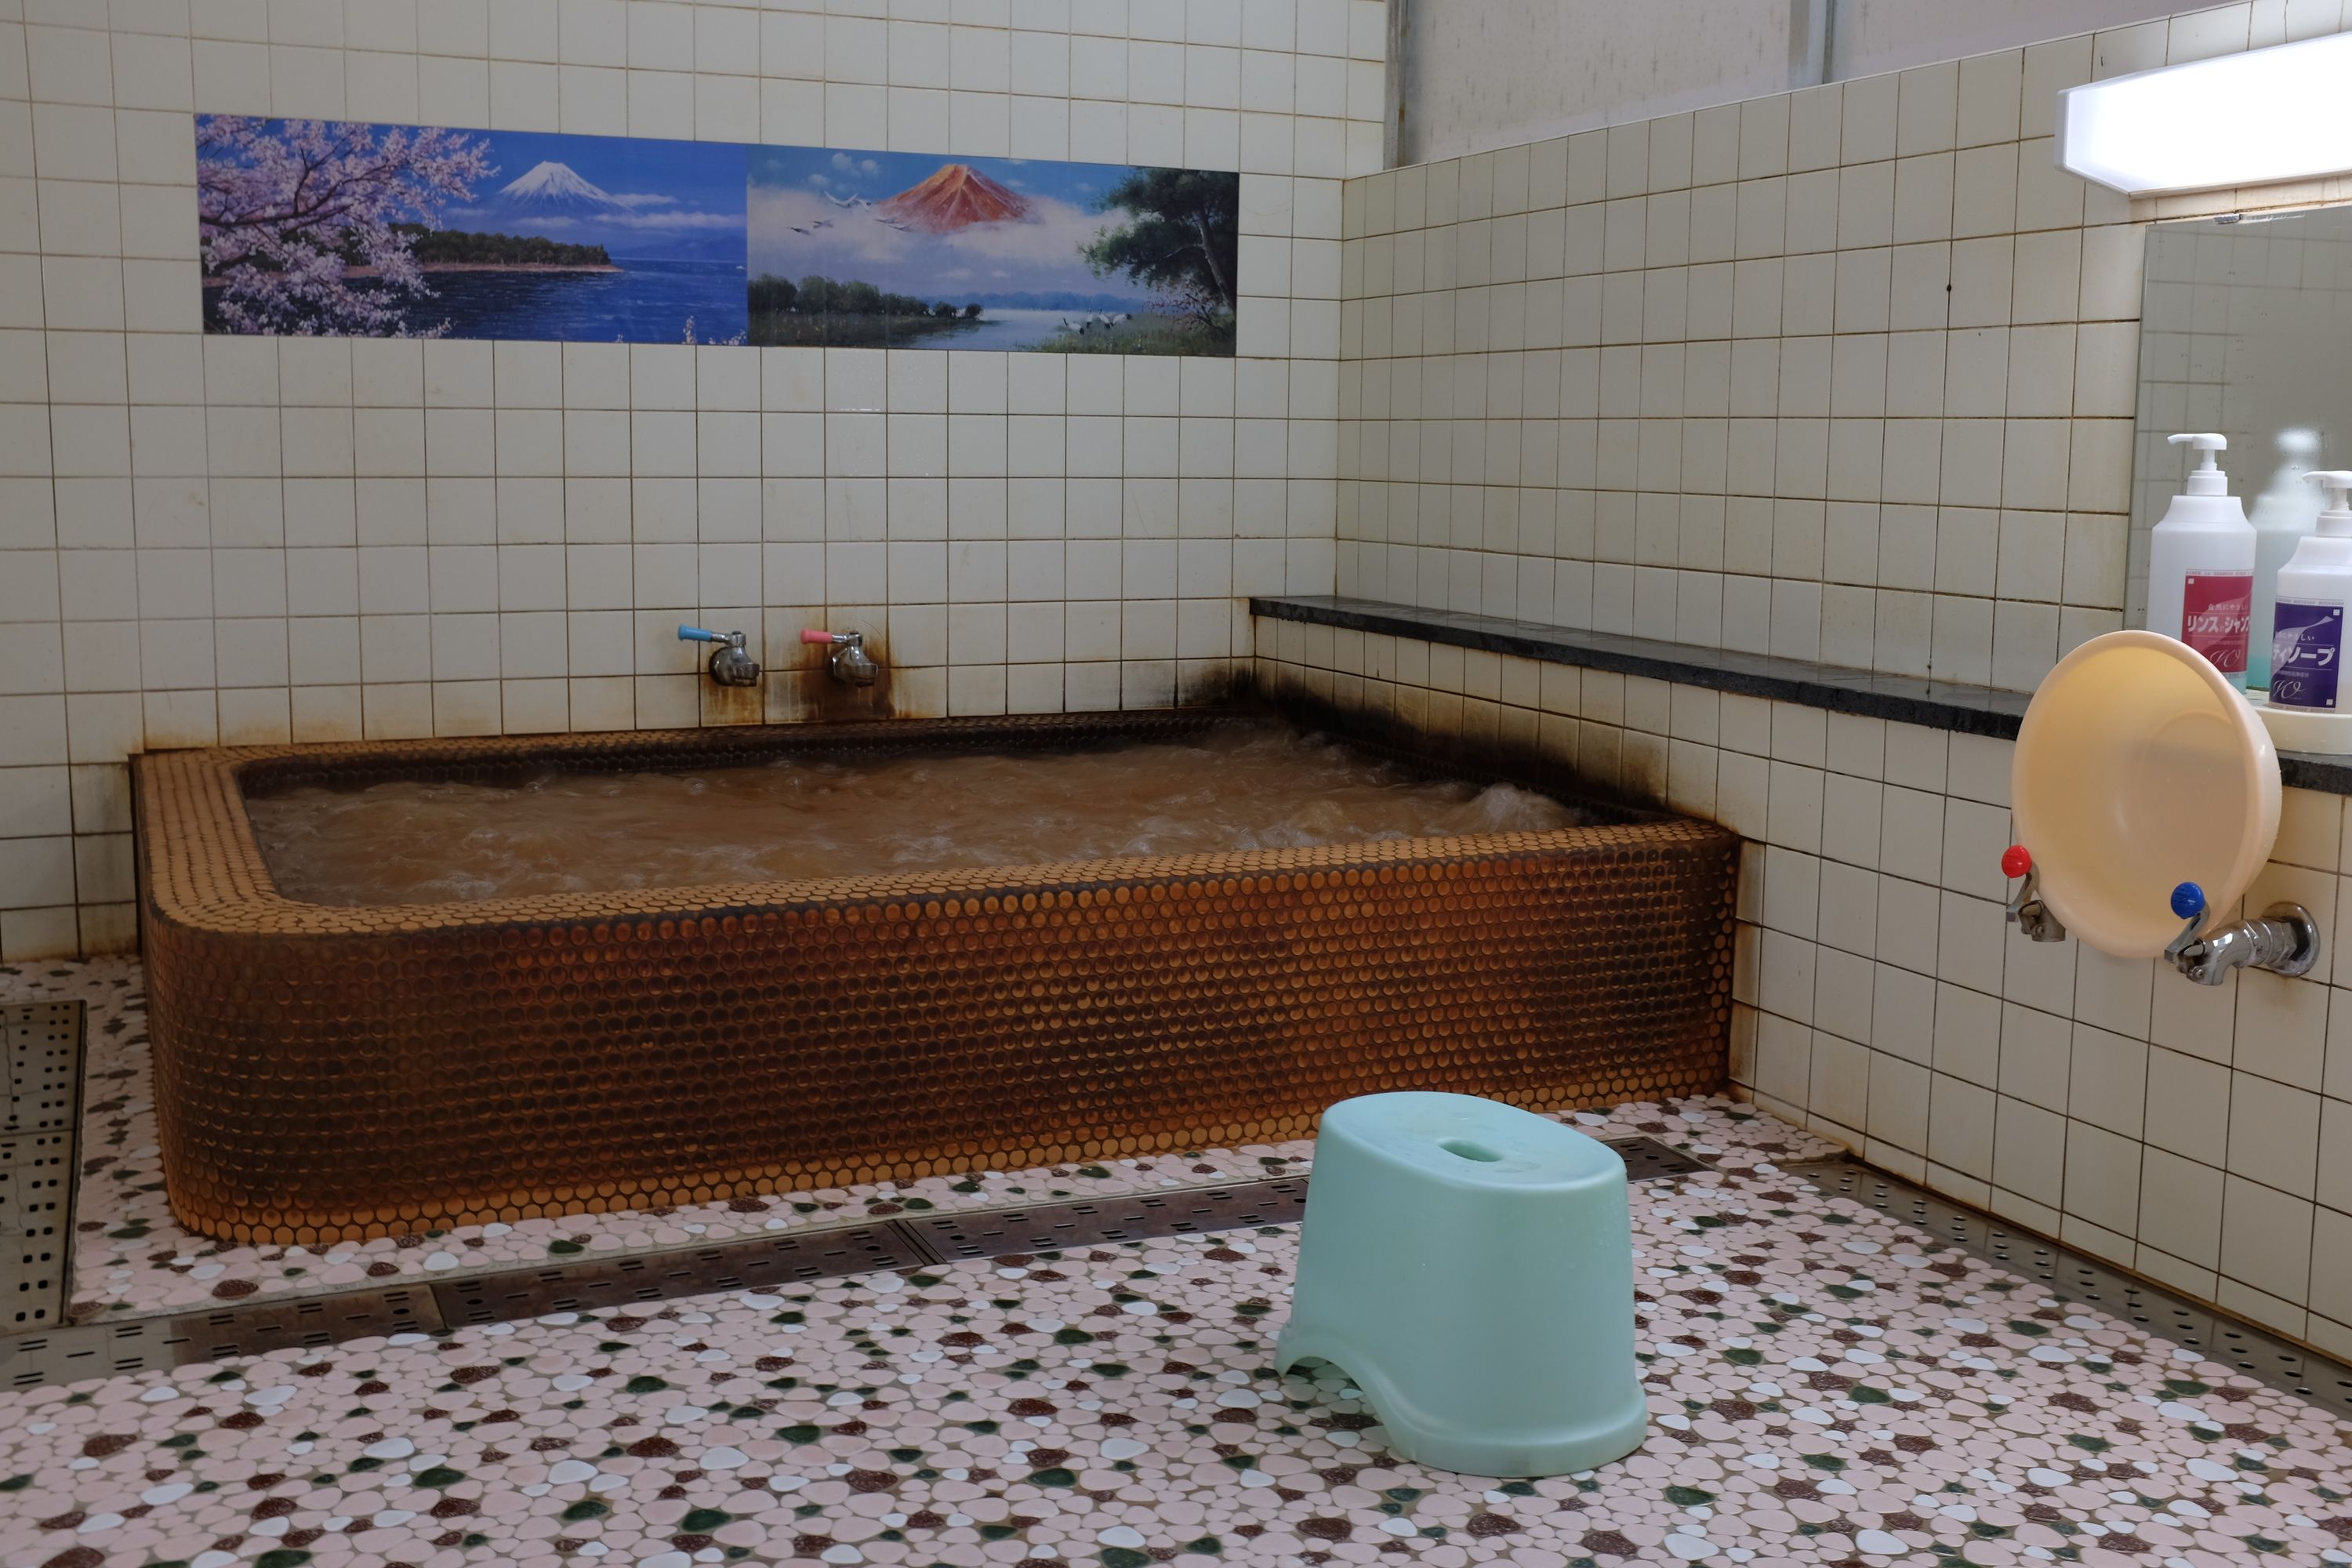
[1249, 595, 2352, 794]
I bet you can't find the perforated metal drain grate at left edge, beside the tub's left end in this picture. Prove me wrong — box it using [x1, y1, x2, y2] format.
[0, 1001, 85, 1333]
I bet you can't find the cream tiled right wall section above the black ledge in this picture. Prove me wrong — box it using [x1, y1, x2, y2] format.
[1338, 0, 2343, 689]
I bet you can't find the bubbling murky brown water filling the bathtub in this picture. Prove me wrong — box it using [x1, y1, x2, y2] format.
[247, 727, 1585, 905]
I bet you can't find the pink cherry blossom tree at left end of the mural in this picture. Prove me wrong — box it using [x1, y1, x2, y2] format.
[195, 115, 492, 336]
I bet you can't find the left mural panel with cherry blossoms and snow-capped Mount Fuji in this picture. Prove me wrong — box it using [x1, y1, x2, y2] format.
[195, 115, 746, 343]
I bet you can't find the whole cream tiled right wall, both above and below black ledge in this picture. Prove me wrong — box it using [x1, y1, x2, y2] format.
[1298, 0, 2352, 1354]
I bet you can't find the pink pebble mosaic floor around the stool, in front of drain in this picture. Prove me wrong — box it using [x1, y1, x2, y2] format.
[13, 971, 2352, 1568]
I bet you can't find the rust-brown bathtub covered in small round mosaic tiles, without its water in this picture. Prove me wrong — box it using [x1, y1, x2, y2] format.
[134, 713, 1738, 1246]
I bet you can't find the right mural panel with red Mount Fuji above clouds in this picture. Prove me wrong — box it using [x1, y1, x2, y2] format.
[746, 148, 1242, 355]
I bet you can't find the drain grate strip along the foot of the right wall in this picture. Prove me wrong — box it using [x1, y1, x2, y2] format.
[1780, 1156, 2352, 1420]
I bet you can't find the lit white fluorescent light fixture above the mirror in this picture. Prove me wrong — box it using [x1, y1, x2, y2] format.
[2058, 33, 2352, 195]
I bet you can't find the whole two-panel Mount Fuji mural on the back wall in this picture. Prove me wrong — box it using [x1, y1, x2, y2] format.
[195, 115, 1240, 355]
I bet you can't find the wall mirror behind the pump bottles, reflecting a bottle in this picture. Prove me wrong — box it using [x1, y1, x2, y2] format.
[2124, 209, 2352, 691]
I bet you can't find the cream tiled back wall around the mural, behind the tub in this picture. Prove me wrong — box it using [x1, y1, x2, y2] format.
[0, 0, 1385, 959]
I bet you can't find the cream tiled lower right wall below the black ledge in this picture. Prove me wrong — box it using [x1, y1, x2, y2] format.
[1258, 621, 2352, 1356]
